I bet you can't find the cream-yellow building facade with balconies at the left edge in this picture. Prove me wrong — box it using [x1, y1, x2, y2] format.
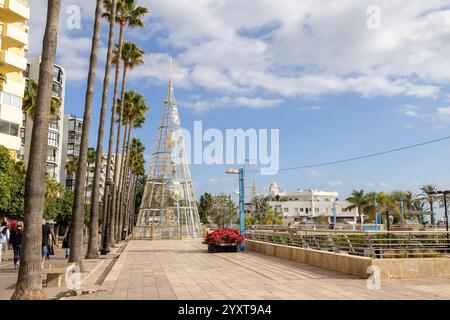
[0, 0, 30, 159]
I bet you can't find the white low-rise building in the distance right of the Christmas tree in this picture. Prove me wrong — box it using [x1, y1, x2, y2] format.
[268, 182, 358, 223]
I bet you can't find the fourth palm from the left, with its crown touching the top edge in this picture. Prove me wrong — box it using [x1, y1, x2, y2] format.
[103, 0, 149, 244]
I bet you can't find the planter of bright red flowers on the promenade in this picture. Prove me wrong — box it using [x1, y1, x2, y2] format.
[203, 228, 245, 252]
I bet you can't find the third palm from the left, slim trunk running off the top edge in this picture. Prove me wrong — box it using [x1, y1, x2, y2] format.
[86, 0, 118, 258]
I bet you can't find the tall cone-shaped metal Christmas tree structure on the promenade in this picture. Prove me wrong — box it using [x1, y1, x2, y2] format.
[134, 80, 201, 239]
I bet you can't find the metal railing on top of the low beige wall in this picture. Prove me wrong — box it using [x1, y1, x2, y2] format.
[246, 230, 450, 259]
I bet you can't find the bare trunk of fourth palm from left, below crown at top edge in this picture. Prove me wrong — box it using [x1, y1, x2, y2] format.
[105, 24, 125, 245]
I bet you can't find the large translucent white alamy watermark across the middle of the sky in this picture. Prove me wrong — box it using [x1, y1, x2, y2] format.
[168, 121, 280, 175]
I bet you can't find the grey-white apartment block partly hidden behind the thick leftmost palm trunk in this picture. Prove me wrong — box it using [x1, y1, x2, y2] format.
[19, 57, 66, 184]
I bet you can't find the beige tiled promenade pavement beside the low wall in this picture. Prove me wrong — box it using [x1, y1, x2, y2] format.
[67, 240, 450, 300]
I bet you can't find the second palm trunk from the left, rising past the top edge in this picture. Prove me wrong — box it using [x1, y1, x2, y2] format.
[69, 0, 103, 264]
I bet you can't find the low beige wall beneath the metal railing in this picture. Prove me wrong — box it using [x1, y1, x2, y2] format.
[245, 240, 450, 279]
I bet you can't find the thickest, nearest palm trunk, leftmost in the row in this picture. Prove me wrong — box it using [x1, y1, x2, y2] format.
[11, 0, 61, 300]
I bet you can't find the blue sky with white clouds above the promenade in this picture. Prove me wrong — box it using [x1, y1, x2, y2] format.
[29, 0, 450, 210]
